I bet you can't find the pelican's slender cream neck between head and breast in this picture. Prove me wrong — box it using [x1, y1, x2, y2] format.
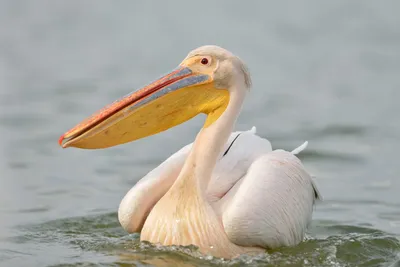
[171, 85, 246, 197]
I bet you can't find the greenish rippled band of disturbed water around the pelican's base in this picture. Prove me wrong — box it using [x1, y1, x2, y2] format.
[11, 216, 400, 266]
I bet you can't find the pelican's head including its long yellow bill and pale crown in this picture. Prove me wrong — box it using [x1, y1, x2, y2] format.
[59, 46, 251, 149]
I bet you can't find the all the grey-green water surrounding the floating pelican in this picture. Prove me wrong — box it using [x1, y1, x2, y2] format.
[0, 0, 400, 266]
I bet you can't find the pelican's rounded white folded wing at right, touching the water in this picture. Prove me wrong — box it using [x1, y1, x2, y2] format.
[214, 142, 319, 248]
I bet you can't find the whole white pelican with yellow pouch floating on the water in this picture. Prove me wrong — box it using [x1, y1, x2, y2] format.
[59, 45, 320, 259]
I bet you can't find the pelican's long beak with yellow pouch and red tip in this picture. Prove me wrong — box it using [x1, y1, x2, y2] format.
[59, 65, 229, 149]
